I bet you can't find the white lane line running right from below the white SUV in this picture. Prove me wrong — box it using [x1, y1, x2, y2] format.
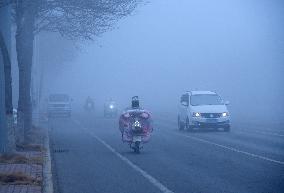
[173, 133, 284, 165]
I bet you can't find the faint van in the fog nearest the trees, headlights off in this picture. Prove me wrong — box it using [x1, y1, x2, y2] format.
[47, 94, 72, 117]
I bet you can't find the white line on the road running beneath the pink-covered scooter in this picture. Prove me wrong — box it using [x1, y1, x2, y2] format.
[74, 120, 174, 193]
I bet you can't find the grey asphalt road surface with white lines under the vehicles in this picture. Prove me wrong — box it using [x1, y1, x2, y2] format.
[49, 114, 284, 193]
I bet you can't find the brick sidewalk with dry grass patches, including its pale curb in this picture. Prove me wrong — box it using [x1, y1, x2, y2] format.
[0, 110, 53, 193]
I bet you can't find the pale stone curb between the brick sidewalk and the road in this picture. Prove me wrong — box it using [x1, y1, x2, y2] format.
[43, 128, 54, 193]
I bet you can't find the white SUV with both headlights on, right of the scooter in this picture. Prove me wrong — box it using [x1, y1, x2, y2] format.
[178, 91, 231, 131]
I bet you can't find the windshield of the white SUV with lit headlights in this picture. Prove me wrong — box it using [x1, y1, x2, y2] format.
[190, 94, 224, 106]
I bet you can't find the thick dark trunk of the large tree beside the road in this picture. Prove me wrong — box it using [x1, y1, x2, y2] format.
[16, 2, 35, 143]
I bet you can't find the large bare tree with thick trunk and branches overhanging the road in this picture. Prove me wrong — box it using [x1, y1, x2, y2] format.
[0, 0, 142, 142]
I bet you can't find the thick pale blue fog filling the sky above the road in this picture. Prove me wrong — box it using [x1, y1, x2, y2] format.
[38, 0, 284, 121]
